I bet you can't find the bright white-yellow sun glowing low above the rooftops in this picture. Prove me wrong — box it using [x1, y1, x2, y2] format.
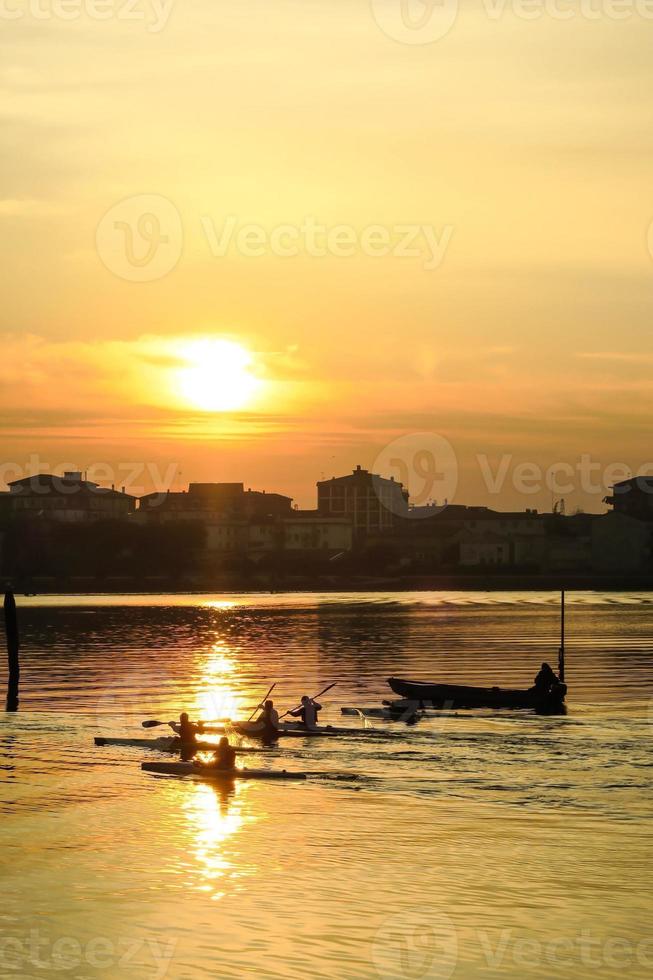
[176, 338, 262, 412]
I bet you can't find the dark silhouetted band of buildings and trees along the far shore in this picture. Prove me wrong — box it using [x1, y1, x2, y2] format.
[0, 466, 653, 578]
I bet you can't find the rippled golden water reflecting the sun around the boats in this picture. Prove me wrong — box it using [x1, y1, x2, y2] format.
[0, 593, 653, 980]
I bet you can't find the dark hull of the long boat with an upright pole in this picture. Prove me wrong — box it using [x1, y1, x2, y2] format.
[388, 677, 567, 713]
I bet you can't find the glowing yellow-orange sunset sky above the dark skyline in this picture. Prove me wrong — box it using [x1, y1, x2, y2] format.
[0, 0, 653, 510]
